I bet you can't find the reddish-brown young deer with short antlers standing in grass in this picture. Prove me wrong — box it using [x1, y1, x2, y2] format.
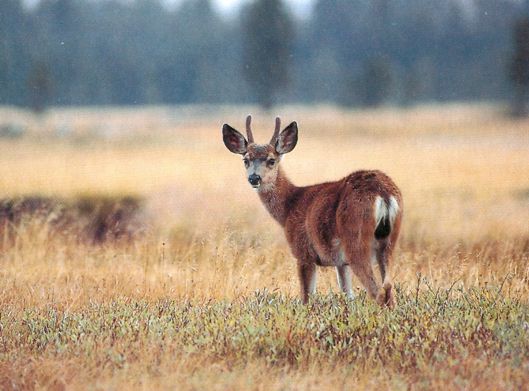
[222, 116, 402, 307]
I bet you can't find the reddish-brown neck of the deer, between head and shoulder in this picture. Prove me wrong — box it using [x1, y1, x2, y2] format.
[259, 168, 297, 226]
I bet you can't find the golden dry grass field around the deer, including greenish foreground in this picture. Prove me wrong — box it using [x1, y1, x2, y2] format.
[0, 105, 529, 390]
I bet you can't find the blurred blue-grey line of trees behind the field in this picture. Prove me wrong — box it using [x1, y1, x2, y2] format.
[0, 0, 529, 110]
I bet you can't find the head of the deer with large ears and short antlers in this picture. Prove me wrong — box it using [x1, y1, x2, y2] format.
[222, 115, 298, 190]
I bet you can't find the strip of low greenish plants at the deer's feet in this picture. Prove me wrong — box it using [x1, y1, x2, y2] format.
[0, 288, 529, 373]
